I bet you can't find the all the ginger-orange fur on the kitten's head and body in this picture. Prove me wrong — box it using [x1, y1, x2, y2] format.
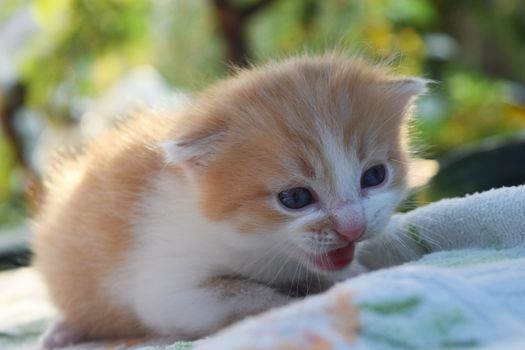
[33, 55, 423, 346]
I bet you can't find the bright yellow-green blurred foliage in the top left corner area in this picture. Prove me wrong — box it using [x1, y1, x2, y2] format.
[24, 0, 151, 118]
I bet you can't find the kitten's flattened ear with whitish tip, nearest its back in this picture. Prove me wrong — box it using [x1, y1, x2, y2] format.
[160, 130, 226, 170]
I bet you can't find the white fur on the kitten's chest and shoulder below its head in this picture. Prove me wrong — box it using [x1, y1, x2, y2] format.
[106, 173, 313, 337]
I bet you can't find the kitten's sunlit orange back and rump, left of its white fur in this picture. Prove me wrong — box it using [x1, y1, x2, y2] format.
[33, 114, 174, 338]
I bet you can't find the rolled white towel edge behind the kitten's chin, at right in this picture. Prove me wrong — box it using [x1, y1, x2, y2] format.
[355, 185, 525, 270]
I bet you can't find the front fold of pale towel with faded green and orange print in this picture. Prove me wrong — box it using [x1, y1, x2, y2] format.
[196, 245, 525, 350]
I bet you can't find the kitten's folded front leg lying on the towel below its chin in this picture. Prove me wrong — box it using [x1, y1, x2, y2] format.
[139, 276, 294, 340]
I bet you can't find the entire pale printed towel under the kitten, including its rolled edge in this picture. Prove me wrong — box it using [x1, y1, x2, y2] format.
[0, 186, 525, 350]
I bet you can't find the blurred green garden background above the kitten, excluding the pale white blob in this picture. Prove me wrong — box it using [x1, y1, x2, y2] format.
[0, 0, 525, 235]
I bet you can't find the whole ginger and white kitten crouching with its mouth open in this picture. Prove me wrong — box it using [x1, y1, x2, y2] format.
[34, 54, 425, 347]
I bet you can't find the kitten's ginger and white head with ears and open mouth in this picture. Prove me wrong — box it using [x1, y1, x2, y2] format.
[164, 55, 425, 272]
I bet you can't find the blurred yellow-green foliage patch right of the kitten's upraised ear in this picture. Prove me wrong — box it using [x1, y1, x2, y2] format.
[417, 70, 525, 155]
